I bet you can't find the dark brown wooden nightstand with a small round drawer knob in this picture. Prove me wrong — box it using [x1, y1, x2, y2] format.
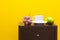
[18, 25, 57, 40]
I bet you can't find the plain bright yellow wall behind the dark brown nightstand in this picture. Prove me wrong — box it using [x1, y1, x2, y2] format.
[0, 0, 60, 40]
